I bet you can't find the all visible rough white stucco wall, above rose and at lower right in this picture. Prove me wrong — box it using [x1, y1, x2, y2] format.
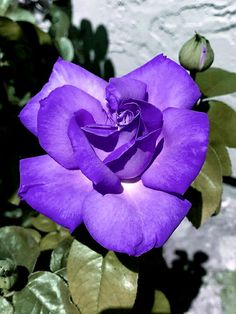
[73, 0, 236, 314]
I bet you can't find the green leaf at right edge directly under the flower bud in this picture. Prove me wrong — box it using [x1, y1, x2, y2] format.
[196, 68, 236, 97]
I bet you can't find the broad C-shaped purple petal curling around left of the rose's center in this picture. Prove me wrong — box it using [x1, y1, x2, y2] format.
[38, 85, 107, 169]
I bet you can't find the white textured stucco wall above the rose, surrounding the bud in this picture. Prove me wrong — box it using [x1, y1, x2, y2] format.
[73, 0, 236, 75]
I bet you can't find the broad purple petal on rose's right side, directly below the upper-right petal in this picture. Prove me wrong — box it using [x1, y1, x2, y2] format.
[142, 108, 209, 194]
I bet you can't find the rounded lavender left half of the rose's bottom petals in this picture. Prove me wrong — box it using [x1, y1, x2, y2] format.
[83, 191, 143, 255]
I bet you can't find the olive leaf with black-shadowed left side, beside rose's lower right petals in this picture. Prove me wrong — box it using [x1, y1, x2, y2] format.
[188, 146, 223, 228]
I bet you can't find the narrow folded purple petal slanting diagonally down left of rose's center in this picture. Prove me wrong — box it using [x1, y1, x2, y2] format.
[68, 116, 122, 194]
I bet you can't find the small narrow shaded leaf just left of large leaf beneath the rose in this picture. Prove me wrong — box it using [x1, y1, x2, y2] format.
[50, 237, 73, 272]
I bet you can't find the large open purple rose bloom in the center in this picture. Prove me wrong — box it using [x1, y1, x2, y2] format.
[19, 55, 209, 256]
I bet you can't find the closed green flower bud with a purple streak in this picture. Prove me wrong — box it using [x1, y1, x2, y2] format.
[179, 33, 214, 72]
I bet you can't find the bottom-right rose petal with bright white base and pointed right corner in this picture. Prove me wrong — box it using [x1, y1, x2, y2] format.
[124, 181, 191, 255]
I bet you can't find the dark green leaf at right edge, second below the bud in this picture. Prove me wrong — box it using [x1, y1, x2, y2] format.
[208, 101, 236, 148]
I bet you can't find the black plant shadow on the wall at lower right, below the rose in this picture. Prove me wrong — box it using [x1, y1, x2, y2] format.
[101, 249, 208, 314]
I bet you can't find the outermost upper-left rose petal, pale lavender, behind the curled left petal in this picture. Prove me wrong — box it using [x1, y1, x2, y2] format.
[19, 58, 107, 135]
